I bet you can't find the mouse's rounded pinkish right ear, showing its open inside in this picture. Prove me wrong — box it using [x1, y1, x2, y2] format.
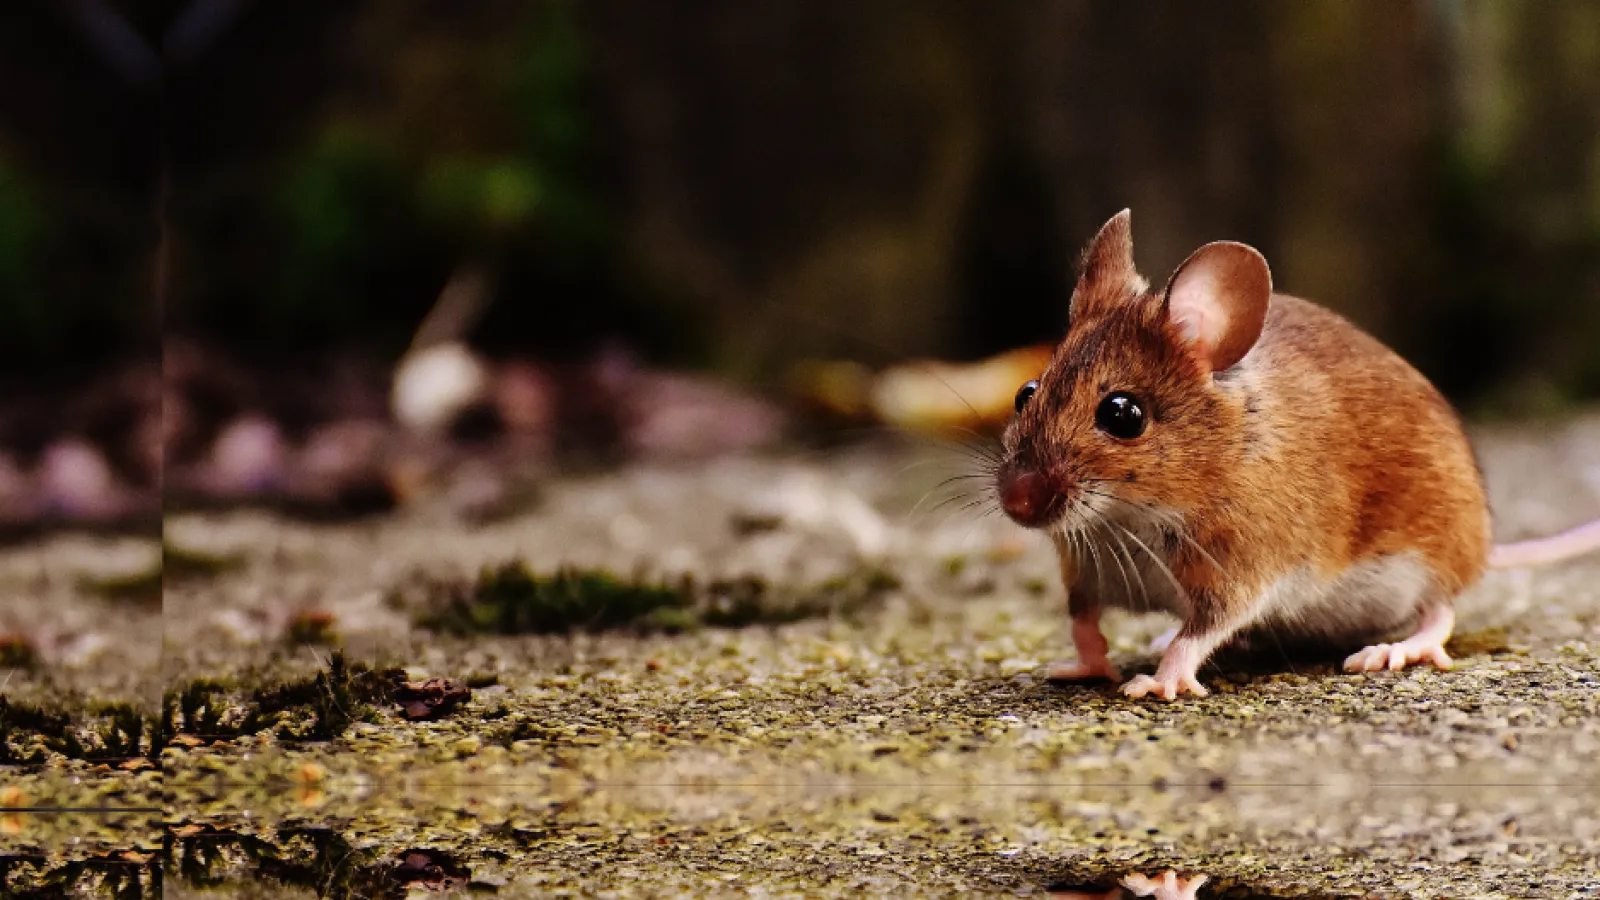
[1162, 240, 1272, 372]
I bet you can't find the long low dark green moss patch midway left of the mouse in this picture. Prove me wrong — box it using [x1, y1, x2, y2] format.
[416, 560, 899, 636]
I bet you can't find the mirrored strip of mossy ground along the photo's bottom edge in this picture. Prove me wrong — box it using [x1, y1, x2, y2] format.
[0, 783, 1574, 900]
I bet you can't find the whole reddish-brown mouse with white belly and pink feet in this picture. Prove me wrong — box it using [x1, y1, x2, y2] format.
[992, 210, 1600, 700]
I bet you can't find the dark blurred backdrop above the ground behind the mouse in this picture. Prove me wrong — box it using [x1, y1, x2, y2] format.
[0, 0, 1600, 525]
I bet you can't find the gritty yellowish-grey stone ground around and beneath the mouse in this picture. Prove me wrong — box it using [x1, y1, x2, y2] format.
[0, 415, 1600, 897]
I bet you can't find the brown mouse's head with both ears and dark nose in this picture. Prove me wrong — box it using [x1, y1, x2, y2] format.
[997, 210, 1272, 533]
